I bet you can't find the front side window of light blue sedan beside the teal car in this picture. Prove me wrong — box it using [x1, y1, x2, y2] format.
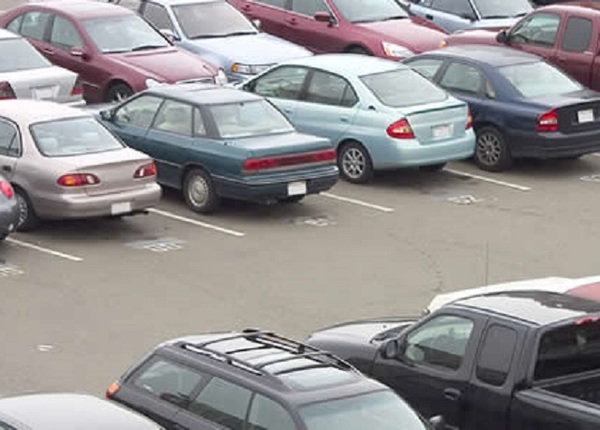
[249, 66, 308, 100]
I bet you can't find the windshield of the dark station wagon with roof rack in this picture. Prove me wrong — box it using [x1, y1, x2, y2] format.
[300, 391, 429, 430]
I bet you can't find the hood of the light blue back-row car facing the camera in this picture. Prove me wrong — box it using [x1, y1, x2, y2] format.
[188, 33, 312, 65]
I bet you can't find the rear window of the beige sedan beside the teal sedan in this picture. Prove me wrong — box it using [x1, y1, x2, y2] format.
[30, 116, 124, 157]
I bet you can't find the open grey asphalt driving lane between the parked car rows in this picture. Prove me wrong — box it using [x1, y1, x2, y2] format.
[0, 155, 600, 395]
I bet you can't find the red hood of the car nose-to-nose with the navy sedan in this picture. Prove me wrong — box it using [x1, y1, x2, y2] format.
[358, 18, 447, 54]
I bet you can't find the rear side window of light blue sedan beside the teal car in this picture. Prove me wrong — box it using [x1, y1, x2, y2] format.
[306, 70, 358, 107]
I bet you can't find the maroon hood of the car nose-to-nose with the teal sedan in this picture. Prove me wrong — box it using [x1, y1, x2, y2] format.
[107, 48, 217, 83]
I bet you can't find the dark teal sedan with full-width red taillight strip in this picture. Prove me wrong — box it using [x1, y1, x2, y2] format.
[100, 84, 339, 213]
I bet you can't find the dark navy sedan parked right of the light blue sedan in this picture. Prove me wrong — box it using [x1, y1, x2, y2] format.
[405, 45, 600, 171]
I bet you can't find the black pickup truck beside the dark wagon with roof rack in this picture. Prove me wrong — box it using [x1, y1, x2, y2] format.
[308, 291, 600, 430]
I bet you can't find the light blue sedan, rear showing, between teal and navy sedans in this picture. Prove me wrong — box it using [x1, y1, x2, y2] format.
[241, 54, 475, 183]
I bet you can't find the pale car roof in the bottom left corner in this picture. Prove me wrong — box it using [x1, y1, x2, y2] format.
[0, 393, 160, 430]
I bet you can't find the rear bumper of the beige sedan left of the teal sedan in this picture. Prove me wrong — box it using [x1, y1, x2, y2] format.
[30, 183, 162, 219]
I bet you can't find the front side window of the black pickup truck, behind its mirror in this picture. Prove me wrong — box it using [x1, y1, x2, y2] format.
[404, 315, 473, 370]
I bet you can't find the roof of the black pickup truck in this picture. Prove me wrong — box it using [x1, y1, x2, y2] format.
[449, 291, 600, 325]
